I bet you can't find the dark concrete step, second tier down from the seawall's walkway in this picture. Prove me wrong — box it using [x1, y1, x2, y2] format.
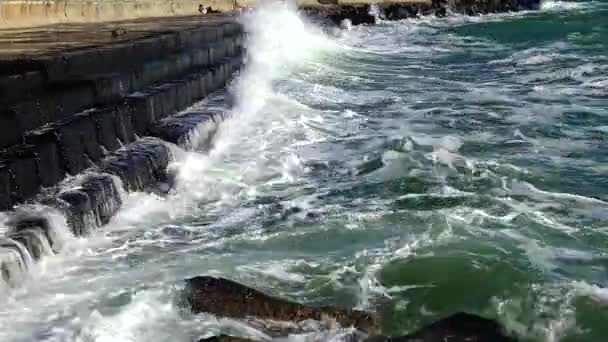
[0, 35, 242, 148]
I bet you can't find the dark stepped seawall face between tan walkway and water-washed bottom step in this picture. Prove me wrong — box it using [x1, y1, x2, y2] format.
[0, 17, 243, 214]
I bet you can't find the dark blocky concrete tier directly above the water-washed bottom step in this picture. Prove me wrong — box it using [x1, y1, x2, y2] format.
[0, 57, 240, 210]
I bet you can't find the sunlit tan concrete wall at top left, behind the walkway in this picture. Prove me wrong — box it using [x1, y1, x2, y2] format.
[0, 0, 247, 28]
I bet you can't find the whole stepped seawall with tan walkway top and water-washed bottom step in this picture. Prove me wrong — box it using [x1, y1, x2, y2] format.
[0, 15, 244, 285]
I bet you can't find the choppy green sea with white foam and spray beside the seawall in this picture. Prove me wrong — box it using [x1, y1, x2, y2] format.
[0, 0, 608, 342]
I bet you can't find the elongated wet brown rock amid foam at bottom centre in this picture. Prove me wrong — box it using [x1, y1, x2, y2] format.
[187, 276, 378, 333]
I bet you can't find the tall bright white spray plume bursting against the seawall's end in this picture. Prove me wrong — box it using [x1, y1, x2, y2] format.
[214, 1, 335, 153]
